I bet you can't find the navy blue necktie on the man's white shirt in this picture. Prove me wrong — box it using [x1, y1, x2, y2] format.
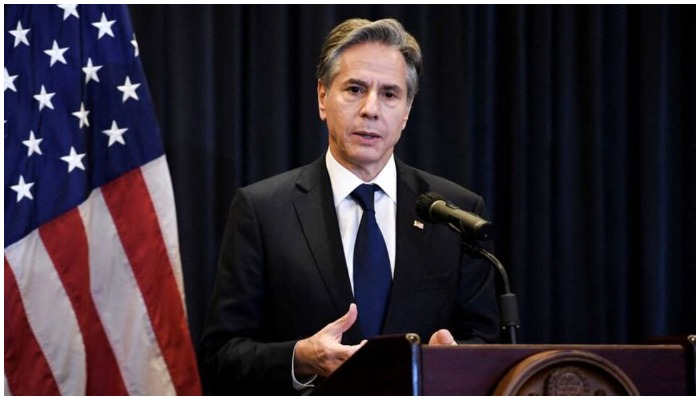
[351, 184, 391, 338]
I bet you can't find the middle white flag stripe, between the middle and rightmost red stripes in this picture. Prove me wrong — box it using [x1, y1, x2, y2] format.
[78, 189, 176, 395]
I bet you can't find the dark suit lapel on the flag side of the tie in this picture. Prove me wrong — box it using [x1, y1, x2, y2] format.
[294, 157, 361, 343]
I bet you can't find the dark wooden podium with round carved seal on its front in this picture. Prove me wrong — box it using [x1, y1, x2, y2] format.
[311, 334, 695, 396]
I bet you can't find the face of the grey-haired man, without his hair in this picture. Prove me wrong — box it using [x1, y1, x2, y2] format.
[318, 43, 411, 181]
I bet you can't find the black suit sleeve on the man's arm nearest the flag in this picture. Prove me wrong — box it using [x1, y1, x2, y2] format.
[200, 189, 296, 395]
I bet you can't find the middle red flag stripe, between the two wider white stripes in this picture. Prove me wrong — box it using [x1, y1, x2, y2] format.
[39, 209, 129, 396]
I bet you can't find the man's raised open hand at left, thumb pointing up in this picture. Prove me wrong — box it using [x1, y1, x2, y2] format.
[294, 304, 366, 377]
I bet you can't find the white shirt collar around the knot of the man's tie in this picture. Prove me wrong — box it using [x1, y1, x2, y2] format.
[326, 149, 396, 206]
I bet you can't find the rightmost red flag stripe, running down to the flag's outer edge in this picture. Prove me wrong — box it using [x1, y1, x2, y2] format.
[101, 169, 201, 395]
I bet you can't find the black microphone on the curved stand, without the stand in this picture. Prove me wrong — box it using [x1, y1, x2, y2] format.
[416, 192, 493, 241]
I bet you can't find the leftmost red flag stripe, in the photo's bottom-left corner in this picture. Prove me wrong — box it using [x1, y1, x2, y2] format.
[5, 258, 61, 396]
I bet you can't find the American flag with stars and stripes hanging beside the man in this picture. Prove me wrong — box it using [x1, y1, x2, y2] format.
[4, 5, 201, 395]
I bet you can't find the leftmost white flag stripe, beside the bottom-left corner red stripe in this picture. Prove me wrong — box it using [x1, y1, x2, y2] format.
[5, 230, 87, 395]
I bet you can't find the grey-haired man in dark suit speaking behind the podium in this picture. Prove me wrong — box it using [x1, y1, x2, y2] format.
[201, 19, 499, 394]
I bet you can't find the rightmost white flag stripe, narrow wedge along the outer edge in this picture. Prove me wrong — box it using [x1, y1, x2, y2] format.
[141, 155, 187, 306]
